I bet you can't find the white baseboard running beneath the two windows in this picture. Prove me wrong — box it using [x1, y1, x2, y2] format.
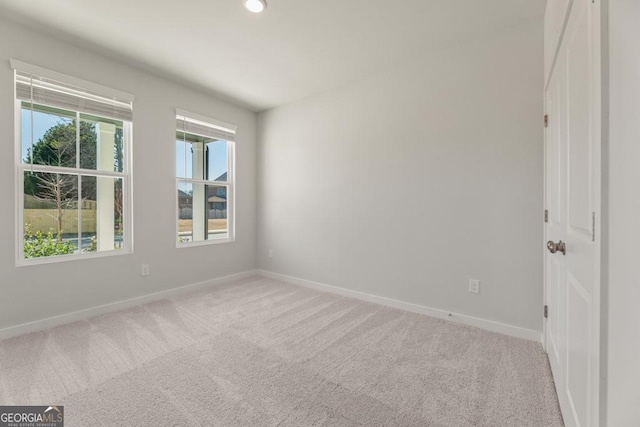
[0, 270, 259, 340]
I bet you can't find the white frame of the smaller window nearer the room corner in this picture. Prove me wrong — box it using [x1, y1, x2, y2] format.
[172, 108, 237, 249]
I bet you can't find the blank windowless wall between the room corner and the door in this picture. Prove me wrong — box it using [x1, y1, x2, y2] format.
[258, 22, 543, 331]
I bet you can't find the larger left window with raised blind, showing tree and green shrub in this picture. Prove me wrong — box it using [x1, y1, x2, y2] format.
[11, 60, 133, 264]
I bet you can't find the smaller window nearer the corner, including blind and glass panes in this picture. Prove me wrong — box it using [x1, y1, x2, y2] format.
[176, 110, 235, 246]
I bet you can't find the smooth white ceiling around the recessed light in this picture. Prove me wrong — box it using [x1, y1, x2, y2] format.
[0, 0, 546, 111]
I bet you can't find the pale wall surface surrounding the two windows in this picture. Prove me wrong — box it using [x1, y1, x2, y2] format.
[0, 19, 256, 330]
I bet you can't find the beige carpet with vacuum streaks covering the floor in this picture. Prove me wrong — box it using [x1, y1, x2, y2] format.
[0, 277, 562, 427]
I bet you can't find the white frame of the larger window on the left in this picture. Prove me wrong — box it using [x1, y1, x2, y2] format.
[11, 65, 133, 267]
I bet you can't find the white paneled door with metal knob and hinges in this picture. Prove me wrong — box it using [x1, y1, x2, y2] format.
[545, 0, 601, 427]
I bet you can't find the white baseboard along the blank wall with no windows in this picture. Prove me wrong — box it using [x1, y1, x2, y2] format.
[258, 270, 542, 342]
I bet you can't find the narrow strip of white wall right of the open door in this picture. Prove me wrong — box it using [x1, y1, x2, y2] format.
[605, 0, 640, 427]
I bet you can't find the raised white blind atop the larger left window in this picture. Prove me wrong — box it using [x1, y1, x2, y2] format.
[11, 60, 133, 122]
